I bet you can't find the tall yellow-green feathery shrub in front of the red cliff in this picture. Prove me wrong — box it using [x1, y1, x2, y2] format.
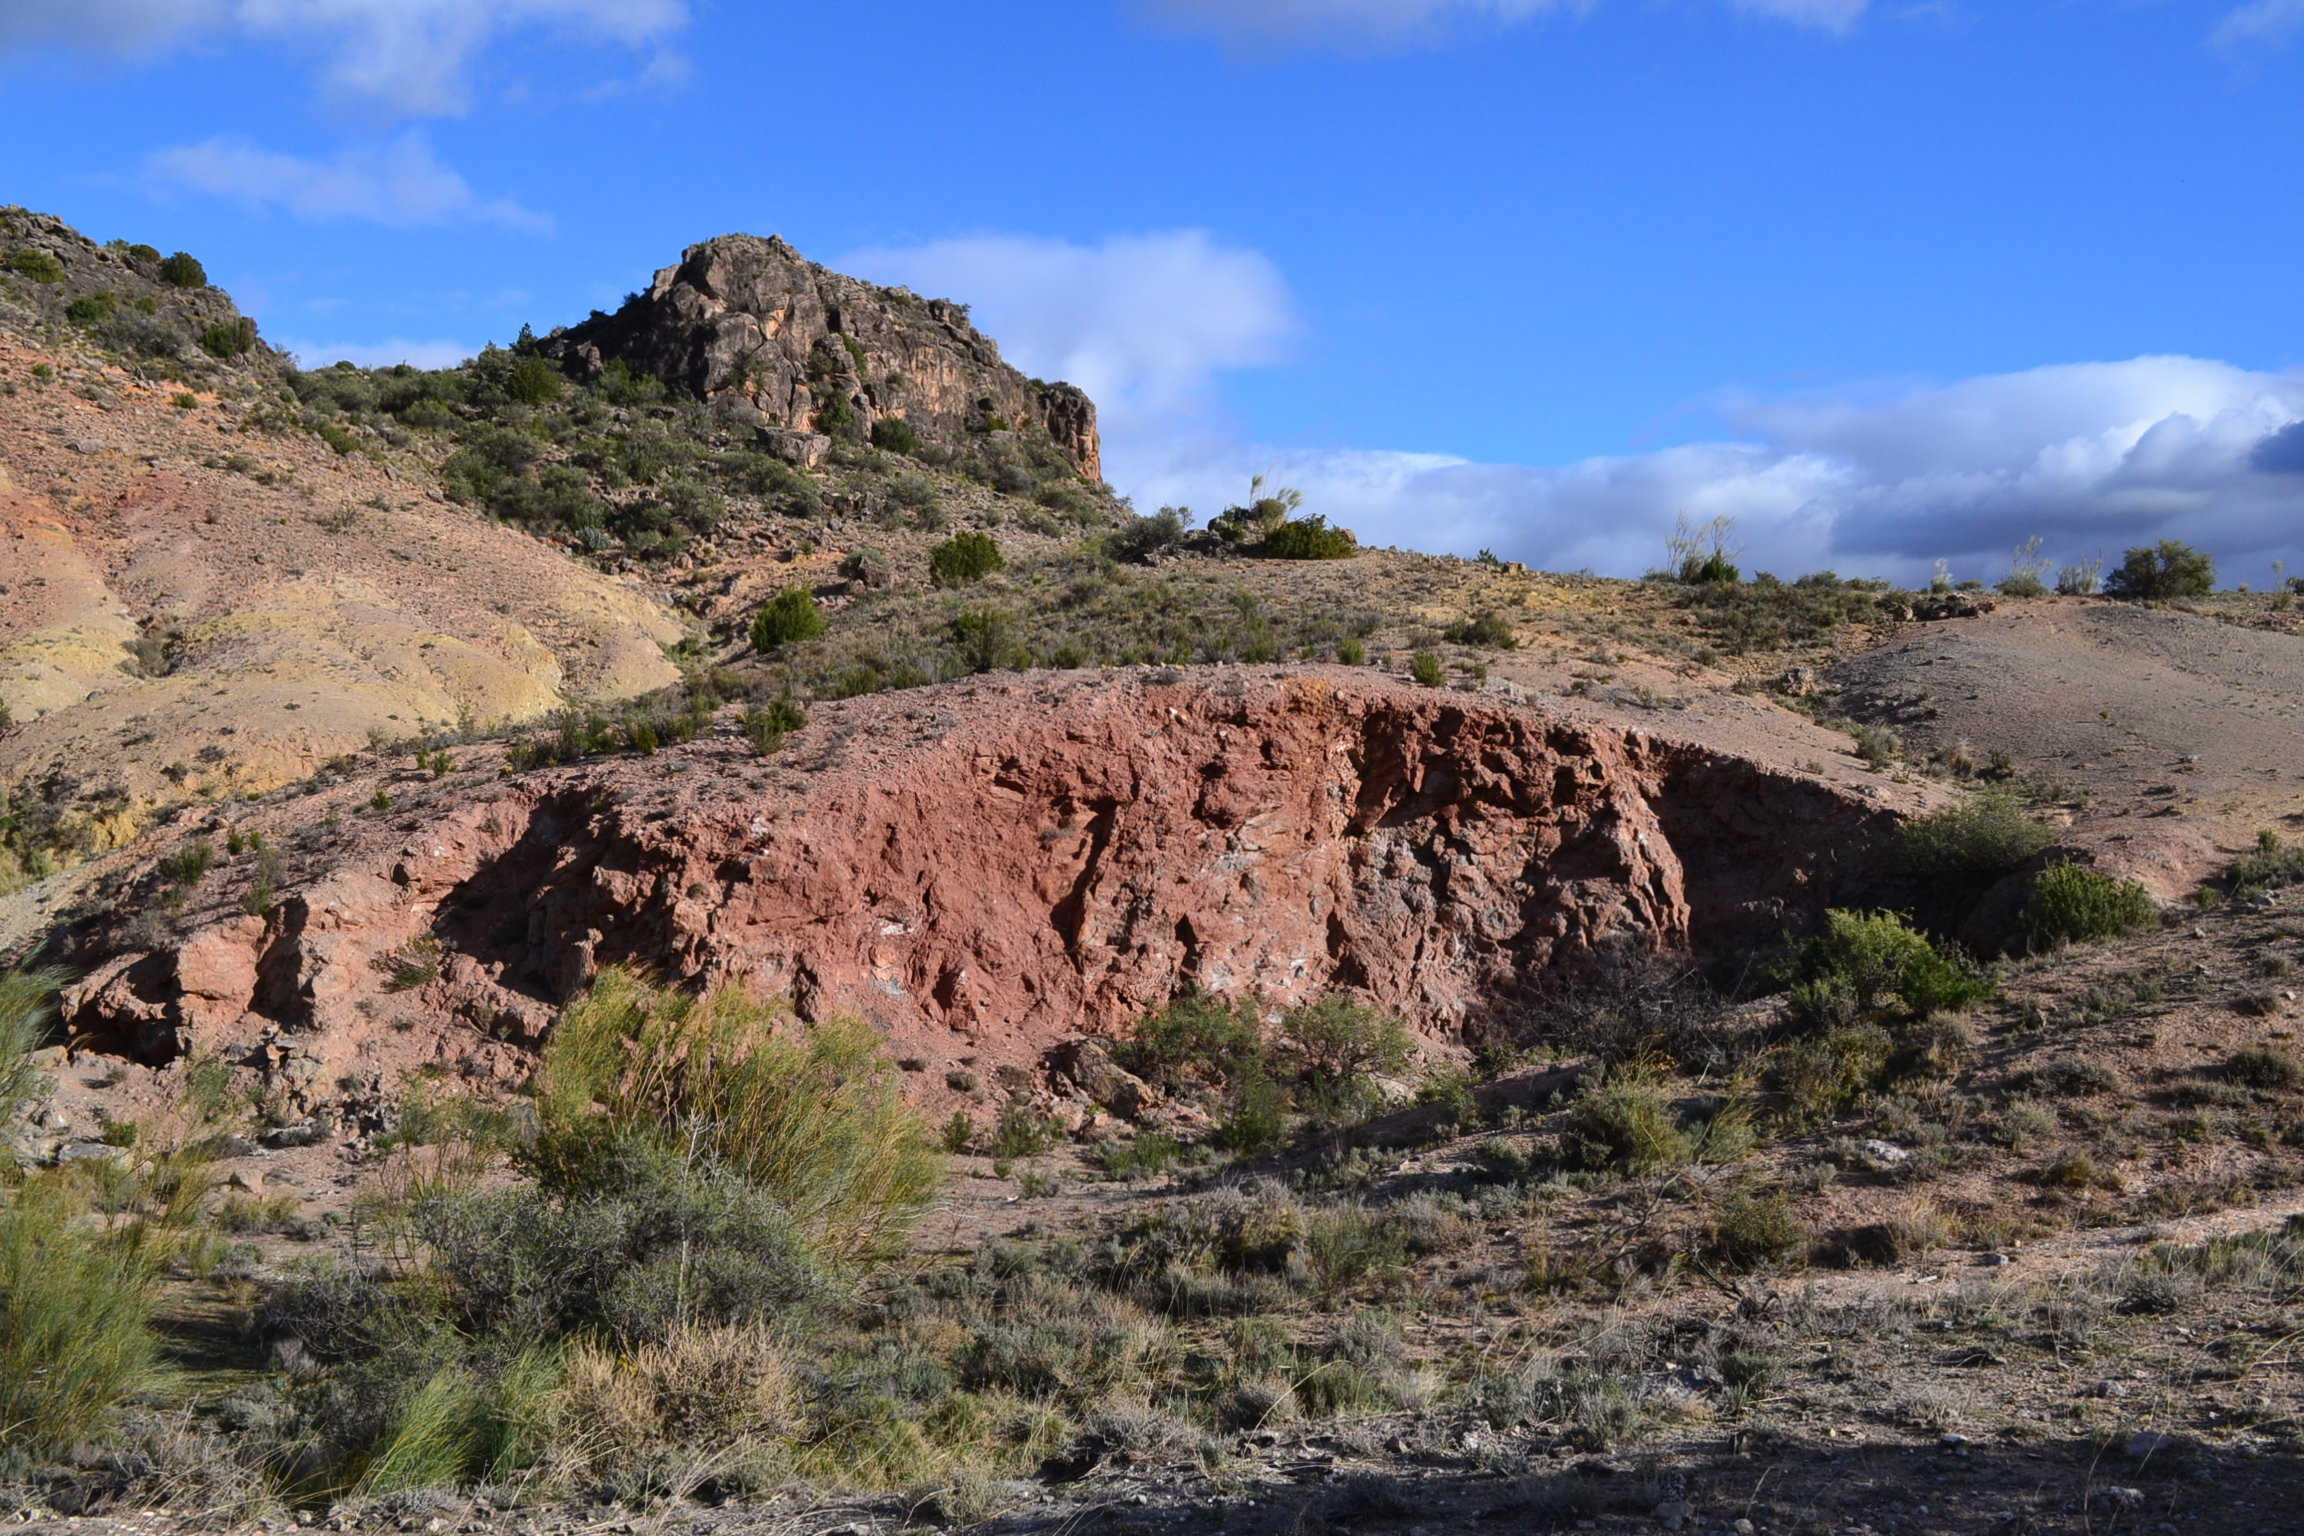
[537, 969, 940, 1262]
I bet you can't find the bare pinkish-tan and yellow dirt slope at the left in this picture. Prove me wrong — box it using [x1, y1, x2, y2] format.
[0, 336, 684, 884]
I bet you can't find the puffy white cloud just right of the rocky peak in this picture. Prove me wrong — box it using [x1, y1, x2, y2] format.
[832, 230, 1297, 433]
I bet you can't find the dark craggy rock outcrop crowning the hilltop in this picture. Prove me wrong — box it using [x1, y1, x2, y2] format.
[544, 235, 1104, 479]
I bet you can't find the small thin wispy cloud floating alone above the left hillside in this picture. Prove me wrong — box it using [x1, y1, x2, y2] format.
[145, 134, 553, 235]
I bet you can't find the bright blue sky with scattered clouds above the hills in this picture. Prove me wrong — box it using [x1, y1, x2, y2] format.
[0, 0, 2304, 585]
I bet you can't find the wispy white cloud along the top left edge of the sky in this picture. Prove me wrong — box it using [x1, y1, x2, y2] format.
[0, 0, 689, 113]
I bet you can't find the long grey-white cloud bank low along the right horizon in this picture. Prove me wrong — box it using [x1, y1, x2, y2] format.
[1124, 357, 2304, 583]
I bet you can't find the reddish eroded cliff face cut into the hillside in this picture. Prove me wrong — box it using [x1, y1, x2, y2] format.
[67, 668, 1926, 1101]
